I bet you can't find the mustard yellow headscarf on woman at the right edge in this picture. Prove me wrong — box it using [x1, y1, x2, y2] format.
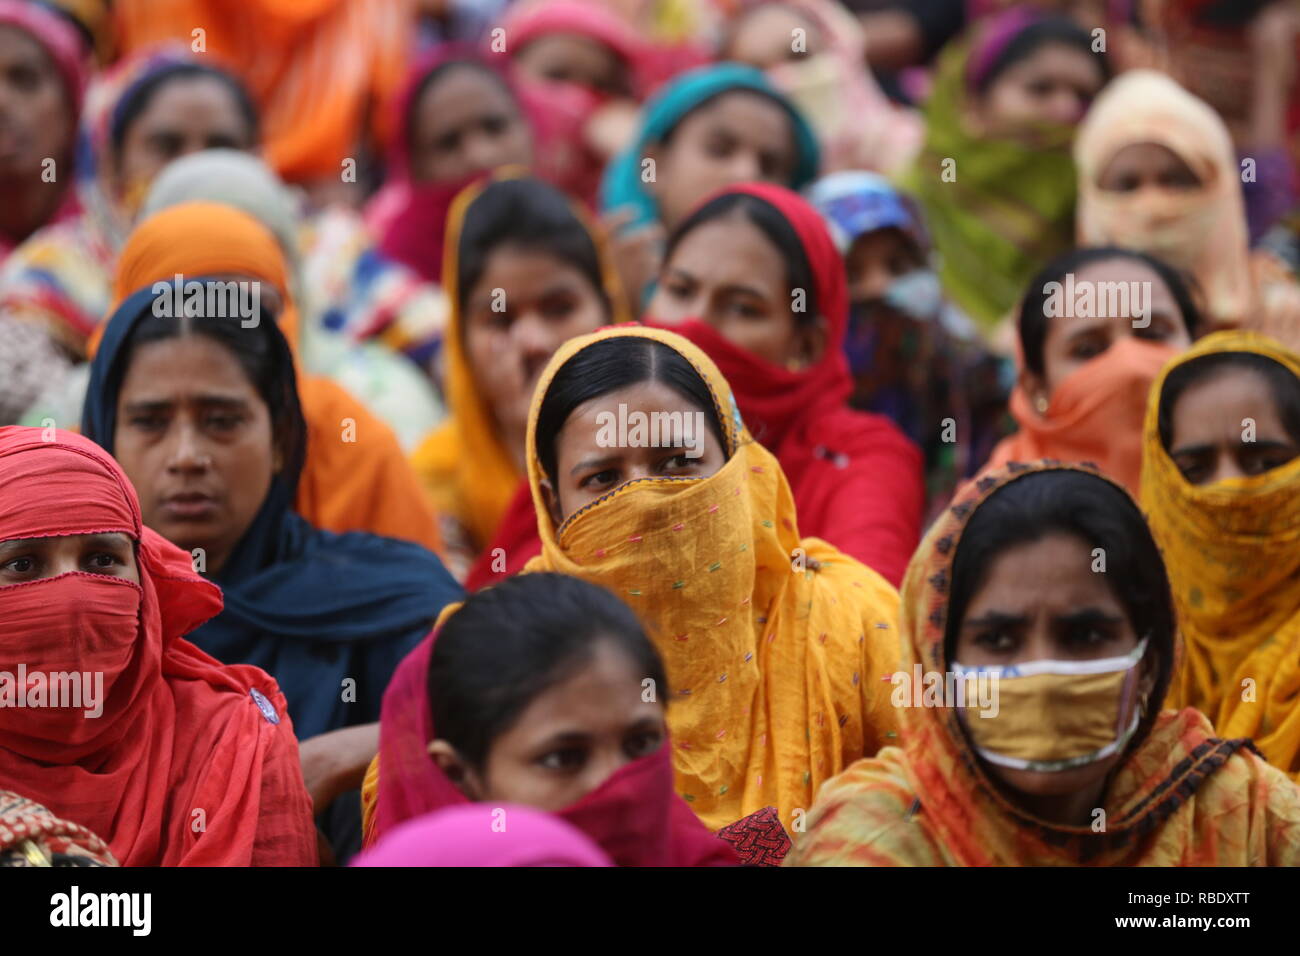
[1141, 332, 1300, 775]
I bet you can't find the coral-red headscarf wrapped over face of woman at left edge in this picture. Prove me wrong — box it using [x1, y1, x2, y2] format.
[0, 427, 316, 866]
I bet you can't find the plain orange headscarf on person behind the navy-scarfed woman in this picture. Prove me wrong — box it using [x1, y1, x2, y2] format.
[100, 202, 441, 551]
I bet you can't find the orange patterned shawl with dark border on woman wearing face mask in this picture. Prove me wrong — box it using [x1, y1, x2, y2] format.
[785, 463, 1300, 866]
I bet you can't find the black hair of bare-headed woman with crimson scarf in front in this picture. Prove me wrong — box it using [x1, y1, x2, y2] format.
[428, 574, 668, 770]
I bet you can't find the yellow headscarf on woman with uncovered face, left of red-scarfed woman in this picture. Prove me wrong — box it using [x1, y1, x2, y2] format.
[411, 174, 628, 561]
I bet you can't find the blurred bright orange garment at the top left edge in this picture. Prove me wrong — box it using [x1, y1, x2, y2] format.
[113, 0, 413, 181]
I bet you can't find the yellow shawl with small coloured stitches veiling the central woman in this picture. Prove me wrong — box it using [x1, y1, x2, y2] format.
[525, 326, 898, 830]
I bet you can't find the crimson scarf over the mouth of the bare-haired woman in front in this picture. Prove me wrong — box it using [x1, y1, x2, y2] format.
[365, 635, 737, 866]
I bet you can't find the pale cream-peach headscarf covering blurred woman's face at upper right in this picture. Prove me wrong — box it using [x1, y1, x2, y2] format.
[1074, 70, 1300, 342]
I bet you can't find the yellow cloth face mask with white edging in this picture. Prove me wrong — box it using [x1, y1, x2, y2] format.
[953, 637, 1147, 773]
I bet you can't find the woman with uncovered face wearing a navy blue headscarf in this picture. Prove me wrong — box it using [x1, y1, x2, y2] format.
[82, 280, 463, 856]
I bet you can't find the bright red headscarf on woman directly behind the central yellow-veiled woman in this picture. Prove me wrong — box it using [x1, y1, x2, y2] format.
[644, 182, 924, 587]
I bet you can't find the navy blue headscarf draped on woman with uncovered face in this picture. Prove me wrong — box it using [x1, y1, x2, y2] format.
[82, 280, 464, 740]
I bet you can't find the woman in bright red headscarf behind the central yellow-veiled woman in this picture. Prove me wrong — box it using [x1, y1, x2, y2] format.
[645, 183, 924, 587]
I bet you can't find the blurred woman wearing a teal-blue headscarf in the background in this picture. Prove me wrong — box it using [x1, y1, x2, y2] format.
[599, 62, 820, 306]
